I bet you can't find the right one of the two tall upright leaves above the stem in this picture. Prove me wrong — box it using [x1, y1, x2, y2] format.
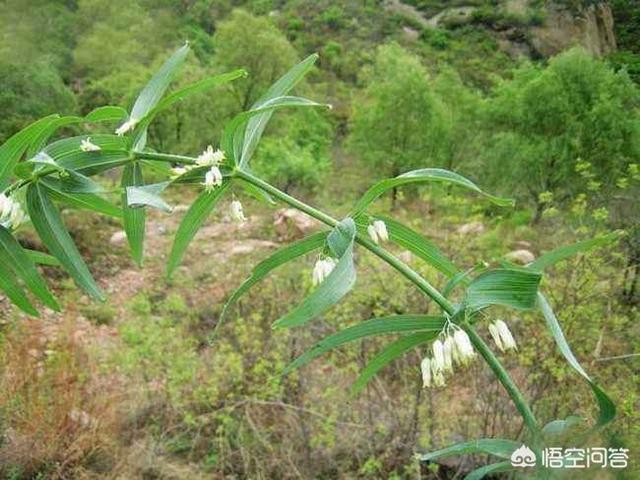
[239, 54, 318, 167]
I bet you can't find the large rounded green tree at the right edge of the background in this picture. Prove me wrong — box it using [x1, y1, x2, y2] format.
[484, 49, 640, 221]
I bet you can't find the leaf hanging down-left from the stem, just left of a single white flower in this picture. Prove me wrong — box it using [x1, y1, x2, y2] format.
[167, 182, 229, 277]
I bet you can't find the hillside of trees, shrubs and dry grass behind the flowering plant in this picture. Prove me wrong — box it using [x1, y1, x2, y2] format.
[0, 0, 640, 479]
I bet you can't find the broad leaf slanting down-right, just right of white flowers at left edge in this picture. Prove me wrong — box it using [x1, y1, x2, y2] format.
[27, 183, 104, 300]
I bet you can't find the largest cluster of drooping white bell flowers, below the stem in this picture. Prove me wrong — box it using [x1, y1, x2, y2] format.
[420, 322, 476, 388]
